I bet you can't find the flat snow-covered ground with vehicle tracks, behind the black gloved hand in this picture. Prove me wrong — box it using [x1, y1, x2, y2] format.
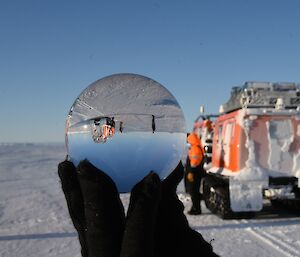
[0, 144, 300, 257]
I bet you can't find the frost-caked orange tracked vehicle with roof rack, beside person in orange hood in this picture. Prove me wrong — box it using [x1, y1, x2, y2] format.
[198, 82, 300, 217]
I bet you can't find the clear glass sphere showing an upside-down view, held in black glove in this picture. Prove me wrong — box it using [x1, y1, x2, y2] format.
[66, 74, 186, 192]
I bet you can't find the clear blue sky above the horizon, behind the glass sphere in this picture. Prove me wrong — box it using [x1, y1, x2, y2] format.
[0, 0, 300, 142]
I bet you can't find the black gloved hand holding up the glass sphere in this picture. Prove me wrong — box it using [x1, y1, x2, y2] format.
[58, 160, 217, 257]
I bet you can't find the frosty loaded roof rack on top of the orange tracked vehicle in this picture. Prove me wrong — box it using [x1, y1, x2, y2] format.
[220, 81, 300, 113]
